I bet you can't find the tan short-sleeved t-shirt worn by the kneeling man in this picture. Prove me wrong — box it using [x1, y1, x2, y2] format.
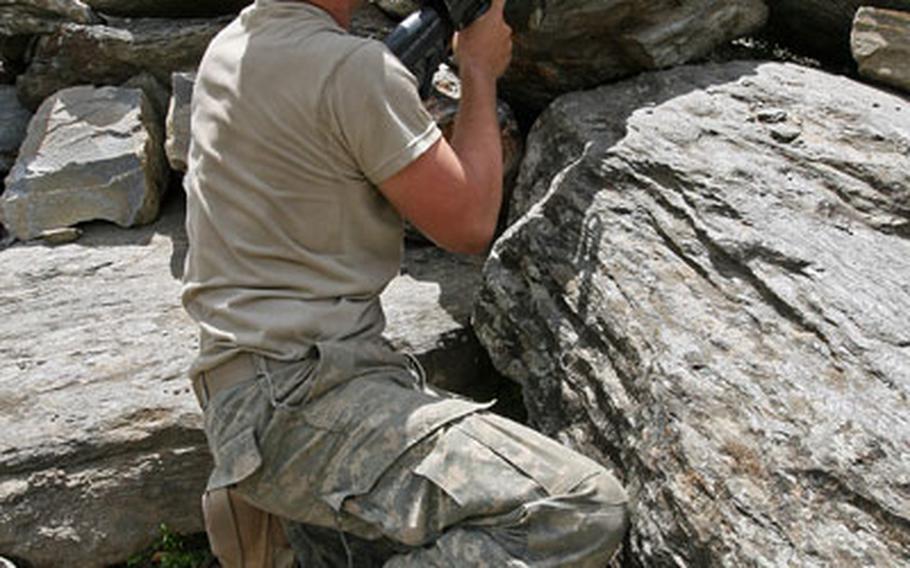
[183, 0, 441, 373]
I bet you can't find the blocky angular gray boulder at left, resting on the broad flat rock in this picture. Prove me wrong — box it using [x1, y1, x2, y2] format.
[0, 87, 168, 240]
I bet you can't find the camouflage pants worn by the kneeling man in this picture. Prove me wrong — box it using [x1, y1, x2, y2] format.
[206, 344, 627, 568]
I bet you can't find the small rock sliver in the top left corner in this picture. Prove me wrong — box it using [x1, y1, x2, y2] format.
[0, 0, 100, 36]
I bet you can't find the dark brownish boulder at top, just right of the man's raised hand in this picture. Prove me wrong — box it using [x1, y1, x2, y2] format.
[503, 0, 767, 109]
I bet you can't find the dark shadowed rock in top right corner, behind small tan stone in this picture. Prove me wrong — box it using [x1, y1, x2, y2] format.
[767, 0, 910, 61]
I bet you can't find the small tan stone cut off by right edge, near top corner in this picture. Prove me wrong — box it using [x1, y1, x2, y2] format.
[850, 8, 910, 92]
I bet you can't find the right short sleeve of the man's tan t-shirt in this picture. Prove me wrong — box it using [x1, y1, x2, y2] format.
[325, 41, 442, 185]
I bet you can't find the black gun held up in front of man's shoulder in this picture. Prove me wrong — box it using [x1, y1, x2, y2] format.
[385, 0, 490, 98]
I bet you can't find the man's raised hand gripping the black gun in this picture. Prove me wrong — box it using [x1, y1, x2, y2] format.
[454, 0, 512, 79]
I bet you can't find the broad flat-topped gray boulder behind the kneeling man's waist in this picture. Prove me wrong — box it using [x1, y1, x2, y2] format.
[0, 192, 495, 568]
